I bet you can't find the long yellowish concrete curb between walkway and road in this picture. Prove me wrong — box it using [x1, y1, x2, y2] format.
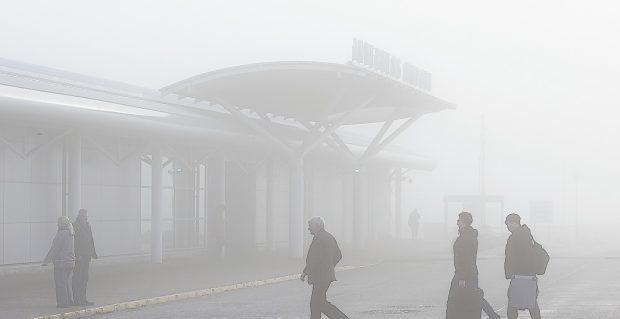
[33, 264, 368, 319]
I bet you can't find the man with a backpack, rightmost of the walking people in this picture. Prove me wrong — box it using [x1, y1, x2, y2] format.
[504, 214, 540, 319]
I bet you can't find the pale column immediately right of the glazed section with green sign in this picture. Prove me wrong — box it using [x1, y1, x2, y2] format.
[207, 156, 226, 256]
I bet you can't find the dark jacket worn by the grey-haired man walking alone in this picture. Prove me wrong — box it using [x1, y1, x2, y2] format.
[304, 229, 342, 284]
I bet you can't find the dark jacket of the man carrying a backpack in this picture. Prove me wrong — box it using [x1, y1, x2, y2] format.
[504, 224, 536, 279]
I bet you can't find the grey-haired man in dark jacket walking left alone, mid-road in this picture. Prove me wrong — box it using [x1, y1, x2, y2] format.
[299, 217, 348, 319]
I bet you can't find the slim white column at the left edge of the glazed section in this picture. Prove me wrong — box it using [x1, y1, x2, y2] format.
[151, 147, 164, 264]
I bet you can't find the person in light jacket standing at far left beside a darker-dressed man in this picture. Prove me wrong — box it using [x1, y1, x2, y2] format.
[43, 216, 75, 308]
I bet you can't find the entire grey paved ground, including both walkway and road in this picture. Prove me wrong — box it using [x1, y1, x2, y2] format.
[0, 244, 620, 319]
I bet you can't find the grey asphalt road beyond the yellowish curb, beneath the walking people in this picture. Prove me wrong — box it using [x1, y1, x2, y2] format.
[95, 258, 620, 319]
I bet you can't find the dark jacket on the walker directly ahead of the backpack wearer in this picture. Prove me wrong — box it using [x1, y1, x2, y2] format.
[452, 226, 478, 280]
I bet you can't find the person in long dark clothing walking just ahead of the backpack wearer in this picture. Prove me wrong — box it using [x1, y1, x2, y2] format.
[446, 212, 500, 319]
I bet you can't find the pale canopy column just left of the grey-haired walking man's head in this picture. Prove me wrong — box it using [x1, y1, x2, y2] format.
[289, 158, 305, 258]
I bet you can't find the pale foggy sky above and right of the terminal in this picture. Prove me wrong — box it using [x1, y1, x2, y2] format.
[0, 0, 620, 223]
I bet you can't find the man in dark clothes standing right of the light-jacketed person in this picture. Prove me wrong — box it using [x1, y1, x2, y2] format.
[73, 209, 98, 306]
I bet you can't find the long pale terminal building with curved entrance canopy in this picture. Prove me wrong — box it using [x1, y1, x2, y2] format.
[0, 53, 454, 265]
